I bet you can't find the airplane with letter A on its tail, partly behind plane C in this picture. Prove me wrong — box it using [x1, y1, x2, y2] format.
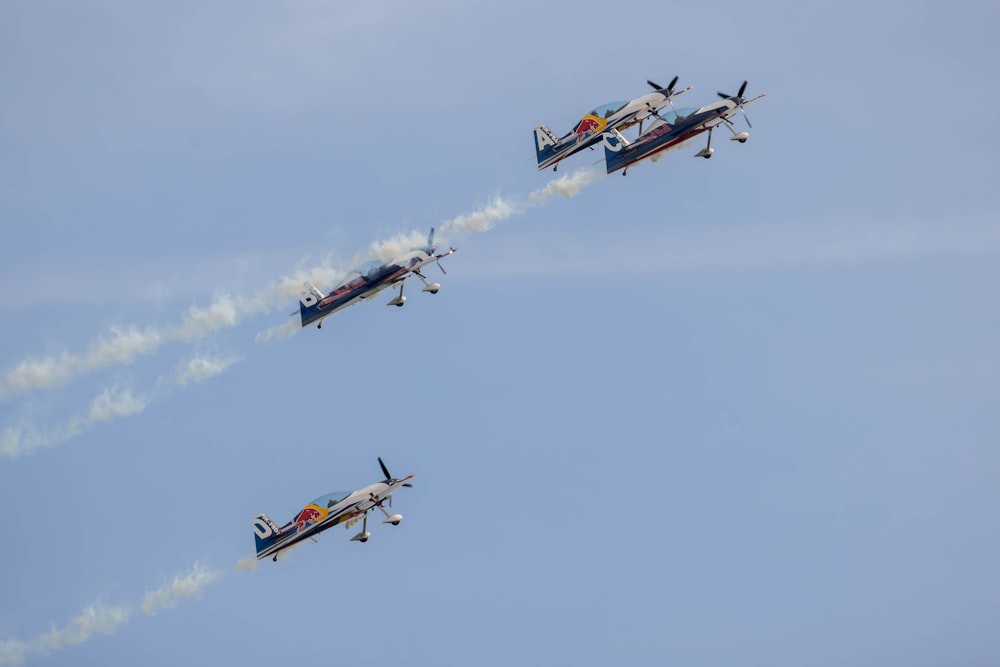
[534, 76, 691, 171]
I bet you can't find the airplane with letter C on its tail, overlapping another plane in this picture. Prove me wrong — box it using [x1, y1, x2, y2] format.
[603, 81, 767, 174]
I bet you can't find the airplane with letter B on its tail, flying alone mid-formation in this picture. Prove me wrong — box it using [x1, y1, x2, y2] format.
[292, 227, 458, 329]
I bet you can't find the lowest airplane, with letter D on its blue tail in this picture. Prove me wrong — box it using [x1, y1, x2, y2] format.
[253, 457, 413, 562]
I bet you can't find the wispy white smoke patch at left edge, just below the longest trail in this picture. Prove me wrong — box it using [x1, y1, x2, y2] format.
[0, 387, 149, 458]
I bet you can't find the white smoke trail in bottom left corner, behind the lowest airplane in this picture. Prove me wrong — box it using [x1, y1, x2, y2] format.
[0, 563, 222, 667]
